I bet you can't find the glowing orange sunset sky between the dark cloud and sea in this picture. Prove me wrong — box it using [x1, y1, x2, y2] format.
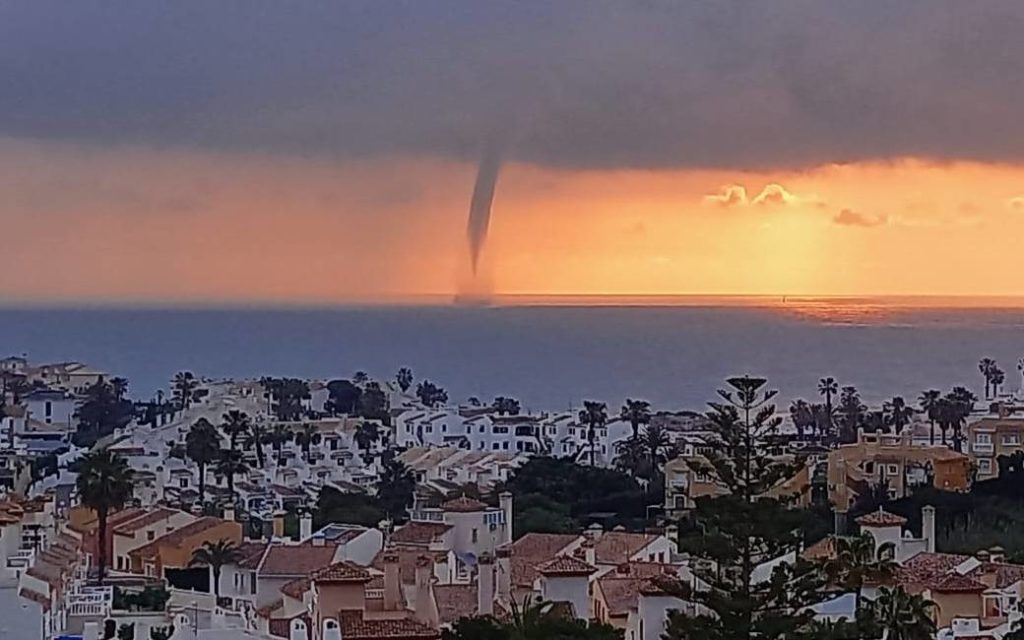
[0, 139, 1024, 302]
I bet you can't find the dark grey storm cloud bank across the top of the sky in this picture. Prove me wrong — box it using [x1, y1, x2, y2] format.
[0, 0, 1024, 169]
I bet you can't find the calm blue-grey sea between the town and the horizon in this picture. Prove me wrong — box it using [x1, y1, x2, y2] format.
[0, 296, 1024, 412]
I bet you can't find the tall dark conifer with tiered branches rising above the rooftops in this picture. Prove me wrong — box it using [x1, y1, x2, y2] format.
[665, 377, 822, 640]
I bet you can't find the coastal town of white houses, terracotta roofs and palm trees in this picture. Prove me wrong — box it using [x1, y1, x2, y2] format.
[6, 356, 1024, 640]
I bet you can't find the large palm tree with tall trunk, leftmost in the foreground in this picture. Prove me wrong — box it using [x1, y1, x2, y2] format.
[75, 450, 132, 585]
